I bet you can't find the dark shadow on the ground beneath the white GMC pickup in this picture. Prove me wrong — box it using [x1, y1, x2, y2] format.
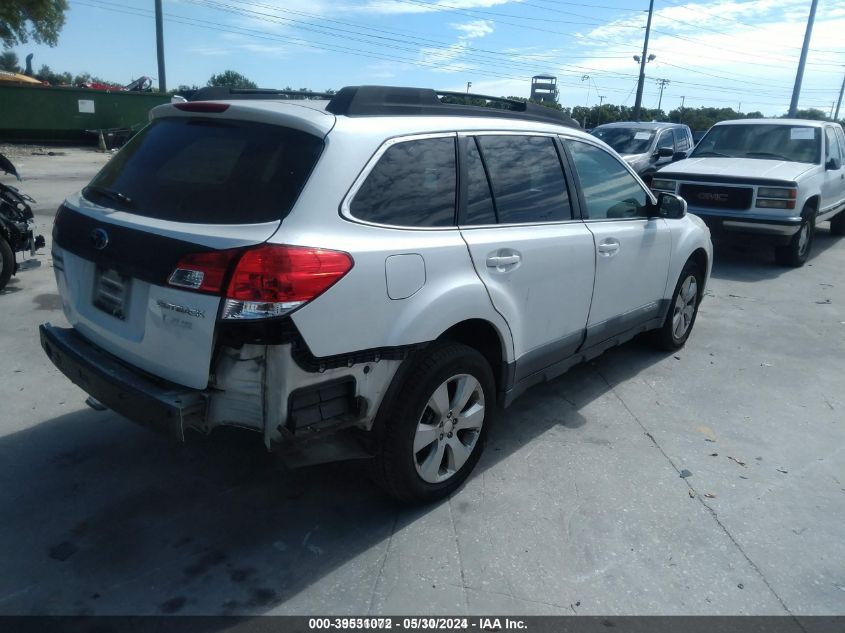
[711, 222, 842, 281]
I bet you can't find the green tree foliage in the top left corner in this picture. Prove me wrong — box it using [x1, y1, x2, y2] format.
[0, 0, 68, 48]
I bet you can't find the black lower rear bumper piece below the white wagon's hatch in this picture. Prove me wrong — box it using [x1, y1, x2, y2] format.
[38, 323, 206, 441]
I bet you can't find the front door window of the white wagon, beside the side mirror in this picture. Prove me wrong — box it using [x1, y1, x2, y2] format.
[566, 140, 649, 220]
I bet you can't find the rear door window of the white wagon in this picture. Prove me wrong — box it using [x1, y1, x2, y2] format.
[477, 136, 572, 224]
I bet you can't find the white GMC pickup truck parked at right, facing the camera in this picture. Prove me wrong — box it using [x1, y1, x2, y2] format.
[651, 119, 845, 266]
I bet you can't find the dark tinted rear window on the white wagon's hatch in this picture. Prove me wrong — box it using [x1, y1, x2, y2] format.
[83, 118, 323, 224]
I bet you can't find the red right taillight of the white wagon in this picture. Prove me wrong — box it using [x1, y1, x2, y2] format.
[169, 244, 353, 319]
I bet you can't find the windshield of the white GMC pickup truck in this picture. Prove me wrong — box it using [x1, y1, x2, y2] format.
[690, 124, 821, 163]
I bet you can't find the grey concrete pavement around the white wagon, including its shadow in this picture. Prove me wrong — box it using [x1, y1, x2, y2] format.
[0, 150, 845, 615]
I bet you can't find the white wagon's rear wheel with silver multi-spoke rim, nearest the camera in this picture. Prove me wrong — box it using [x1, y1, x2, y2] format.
[373, 342, 495, 503]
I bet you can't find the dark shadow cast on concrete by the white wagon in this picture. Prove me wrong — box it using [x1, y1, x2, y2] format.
[0, 340, 665, 626]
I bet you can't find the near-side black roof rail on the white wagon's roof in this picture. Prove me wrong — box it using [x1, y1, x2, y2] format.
[326, 86, 581, 129]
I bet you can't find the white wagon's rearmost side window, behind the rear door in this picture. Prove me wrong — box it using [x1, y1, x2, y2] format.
[349, 137, 457, 227]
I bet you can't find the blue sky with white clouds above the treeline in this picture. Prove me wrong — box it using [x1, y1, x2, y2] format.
[6, 0, 845, 116]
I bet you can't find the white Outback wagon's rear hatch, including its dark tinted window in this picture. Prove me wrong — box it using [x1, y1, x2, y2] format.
[53, 102, 334, 389]
